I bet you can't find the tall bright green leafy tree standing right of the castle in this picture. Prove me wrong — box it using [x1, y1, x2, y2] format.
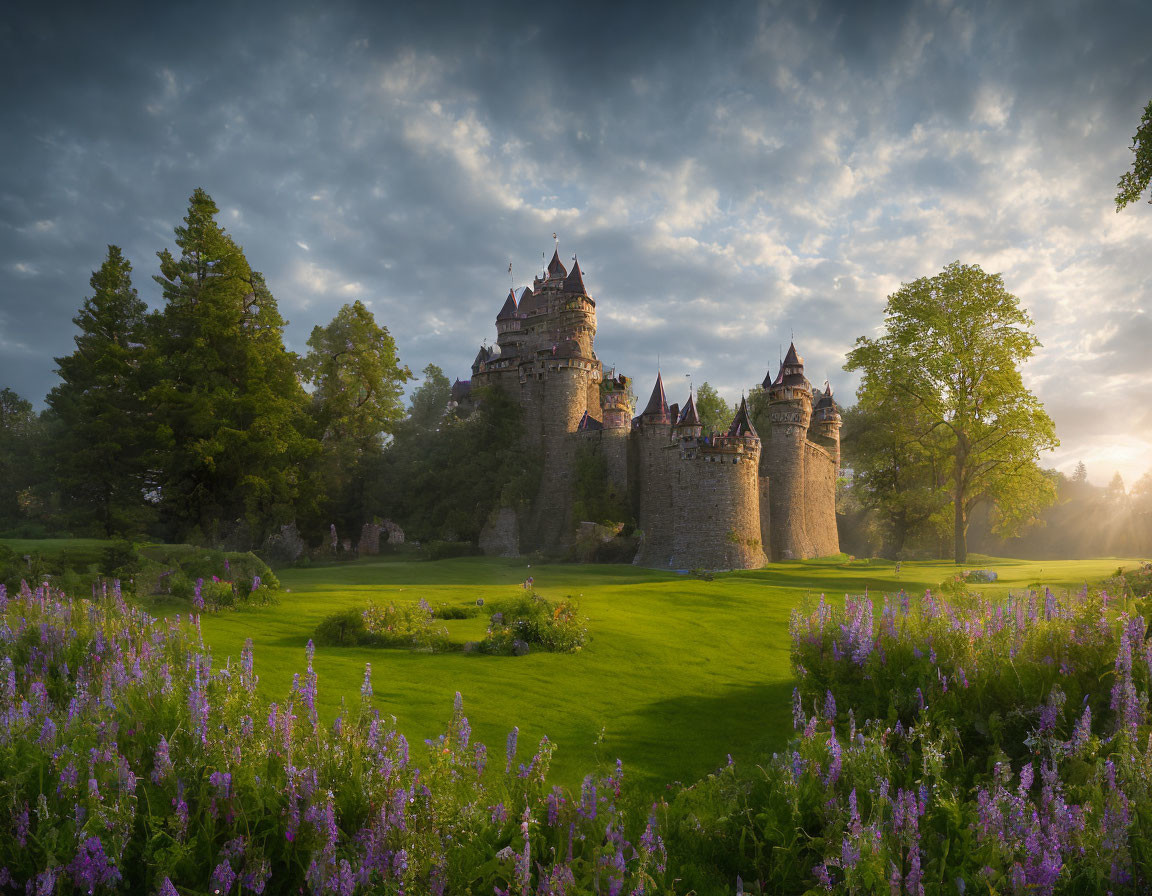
[844, 261, 1059, 563]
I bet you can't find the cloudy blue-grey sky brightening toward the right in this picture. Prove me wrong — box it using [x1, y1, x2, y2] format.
[0, 0, 1152, 484]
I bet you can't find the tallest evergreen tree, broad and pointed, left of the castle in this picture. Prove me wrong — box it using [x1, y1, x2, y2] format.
[153, 189, 319, 540]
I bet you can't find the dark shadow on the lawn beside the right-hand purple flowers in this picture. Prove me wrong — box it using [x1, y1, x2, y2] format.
[605, 678, 794, 789]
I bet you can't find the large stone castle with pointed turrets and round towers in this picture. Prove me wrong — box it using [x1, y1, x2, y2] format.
[452, 249, 840, 569]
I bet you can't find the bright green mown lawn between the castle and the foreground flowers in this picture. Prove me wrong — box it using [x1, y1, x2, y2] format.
[191, 557, 1135, 791]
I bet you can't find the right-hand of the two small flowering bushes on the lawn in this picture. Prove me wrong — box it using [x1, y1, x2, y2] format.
[480, 591, 588, 656]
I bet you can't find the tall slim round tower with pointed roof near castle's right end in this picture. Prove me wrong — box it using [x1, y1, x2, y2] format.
[760, 344, 816, 560]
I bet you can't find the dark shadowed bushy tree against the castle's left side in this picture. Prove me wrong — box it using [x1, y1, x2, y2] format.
[367, 389, 540, 542]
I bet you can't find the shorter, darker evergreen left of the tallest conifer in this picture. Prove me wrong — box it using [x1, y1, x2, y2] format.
[47, 245, 150, 536]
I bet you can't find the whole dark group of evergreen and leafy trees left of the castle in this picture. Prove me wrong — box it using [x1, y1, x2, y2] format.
[0, 190, 531, 549]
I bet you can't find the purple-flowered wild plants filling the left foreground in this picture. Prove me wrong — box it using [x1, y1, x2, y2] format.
[0, 580, 673, 896]
